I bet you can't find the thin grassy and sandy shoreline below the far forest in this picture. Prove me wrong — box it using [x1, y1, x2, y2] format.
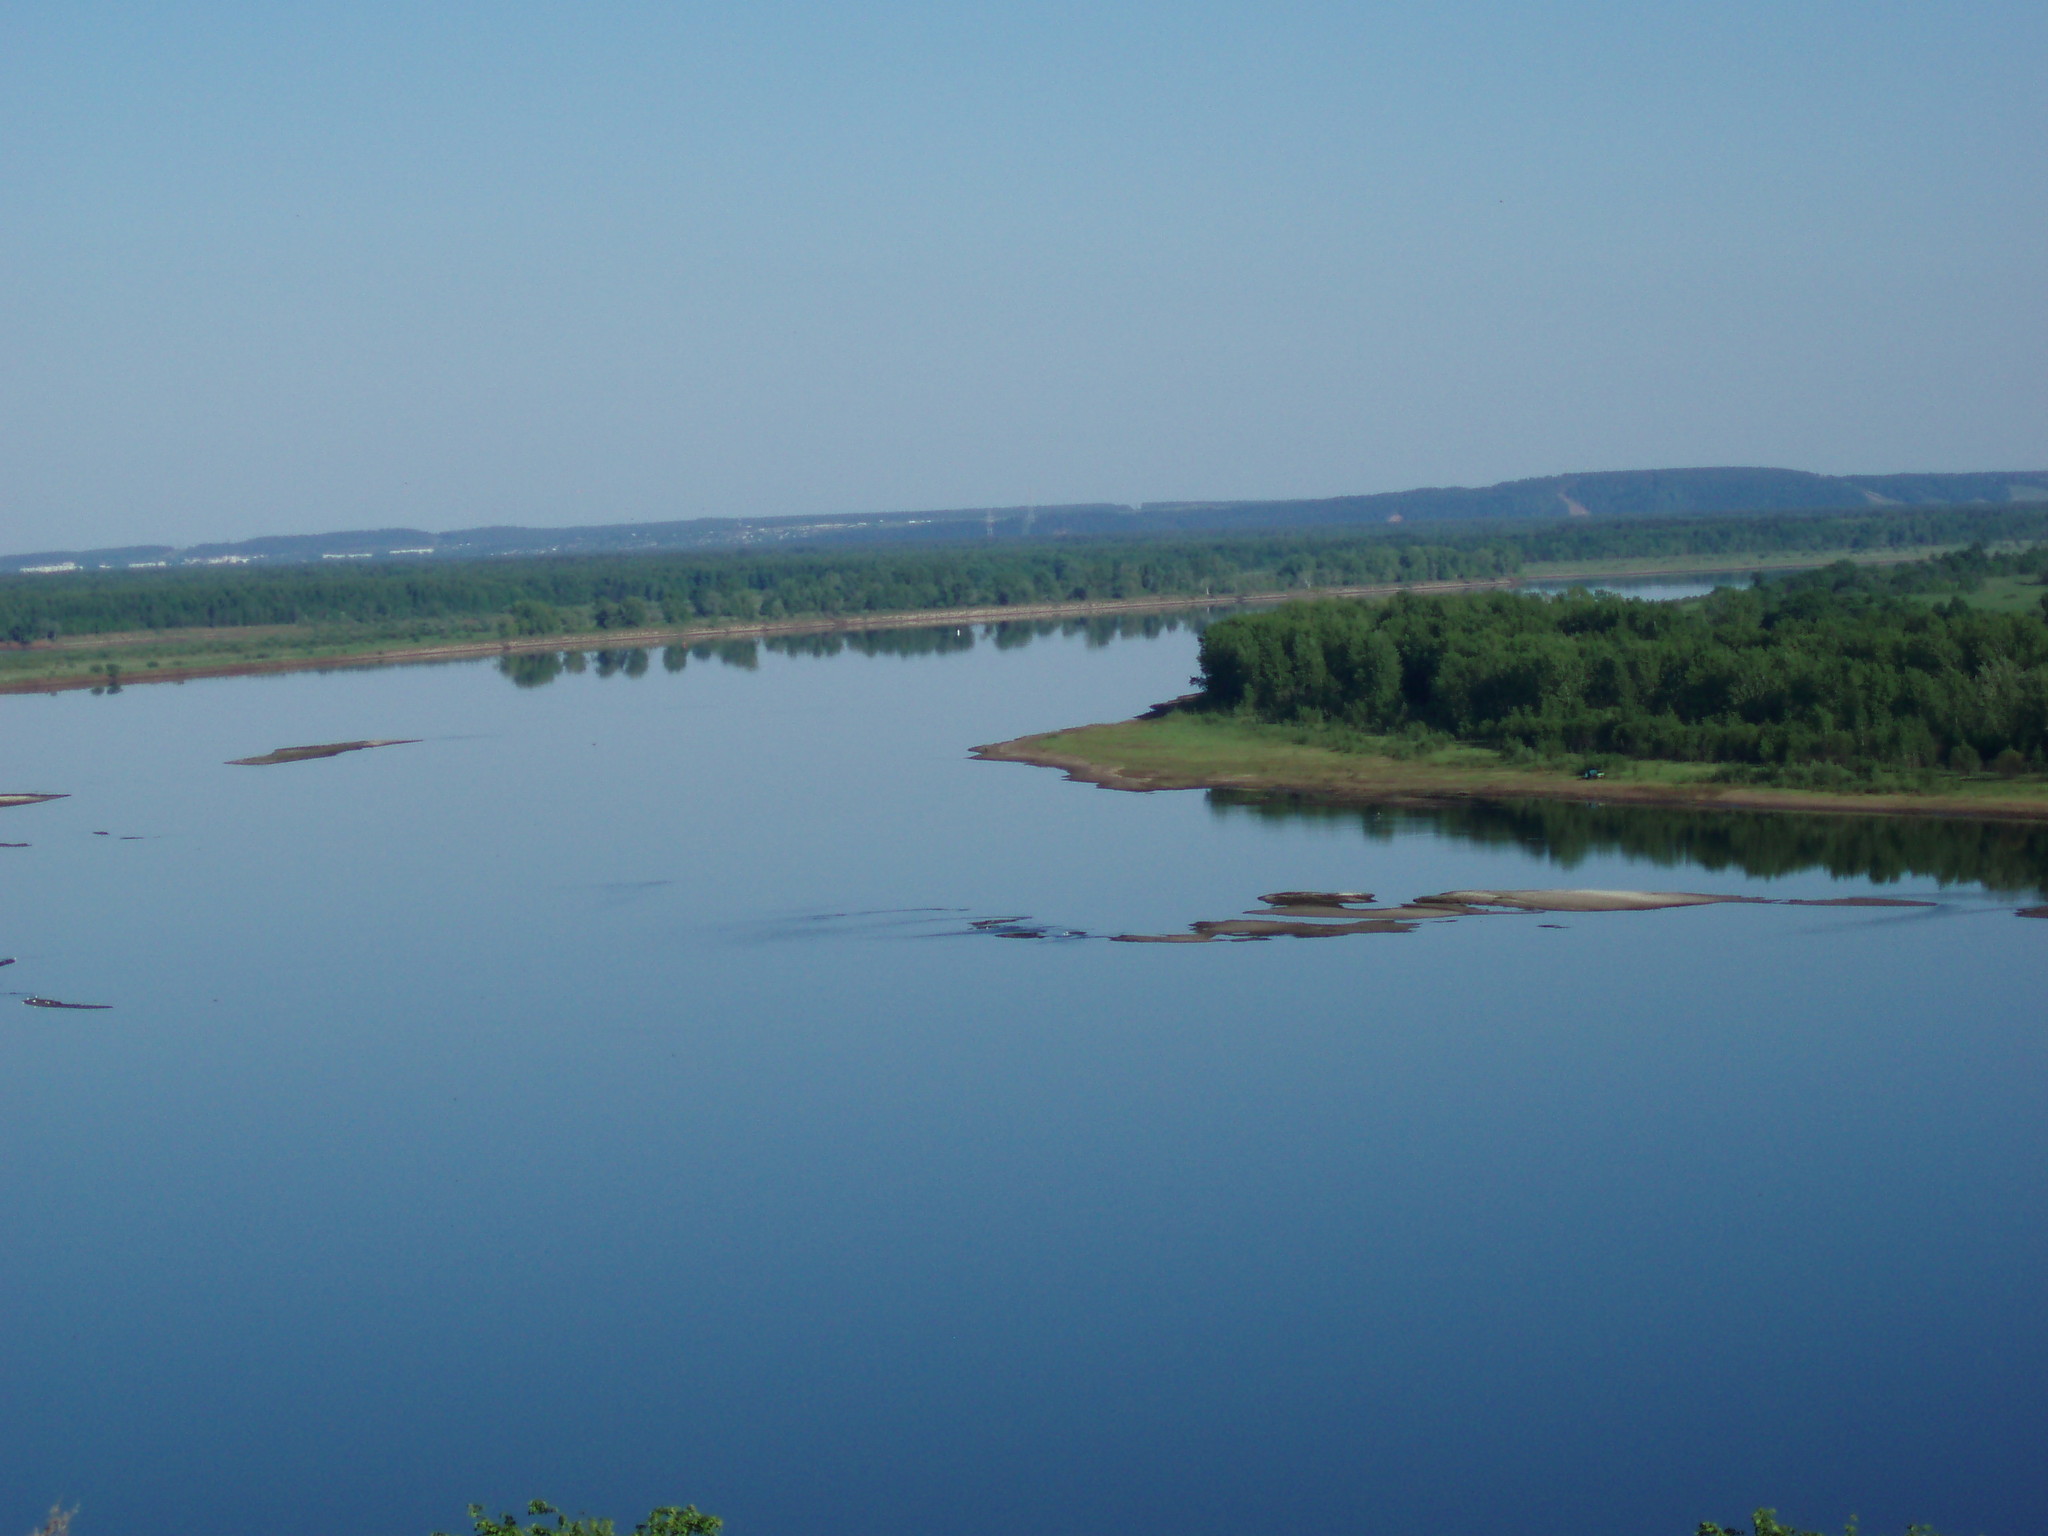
[0, 547, 1935, 694]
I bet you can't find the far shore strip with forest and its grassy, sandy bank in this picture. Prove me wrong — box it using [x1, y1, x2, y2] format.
[0, 506, 2048, 688]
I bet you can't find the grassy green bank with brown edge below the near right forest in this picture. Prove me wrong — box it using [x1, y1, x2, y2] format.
[973, 709, 2048, 821]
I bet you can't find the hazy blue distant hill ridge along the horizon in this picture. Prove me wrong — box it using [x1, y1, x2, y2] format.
[0, 469, 2048, 573]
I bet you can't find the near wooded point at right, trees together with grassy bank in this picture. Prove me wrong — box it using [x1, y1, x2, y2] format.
[983, 545, 2048, 819]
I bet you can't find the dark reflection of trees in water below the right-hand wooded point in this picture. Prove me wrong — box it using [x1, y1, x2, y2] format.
[1208, 791, 2048, 893]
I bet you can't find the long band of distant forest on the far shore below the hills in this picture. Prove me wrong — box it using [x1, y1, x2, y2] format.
[0, 506, 2048, 645]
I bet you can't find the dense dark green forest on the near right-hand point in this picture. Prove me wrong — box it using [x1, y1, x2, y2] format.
[1200, 549, 2048, 782]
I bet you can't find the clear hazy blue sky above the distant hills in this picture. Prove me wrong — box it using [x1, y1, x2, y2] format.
[0, 0, 2048, 551]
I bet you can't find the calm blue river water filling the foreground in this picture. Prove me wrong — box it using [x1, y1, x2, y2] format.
[0, 631, 2048, 1536]
